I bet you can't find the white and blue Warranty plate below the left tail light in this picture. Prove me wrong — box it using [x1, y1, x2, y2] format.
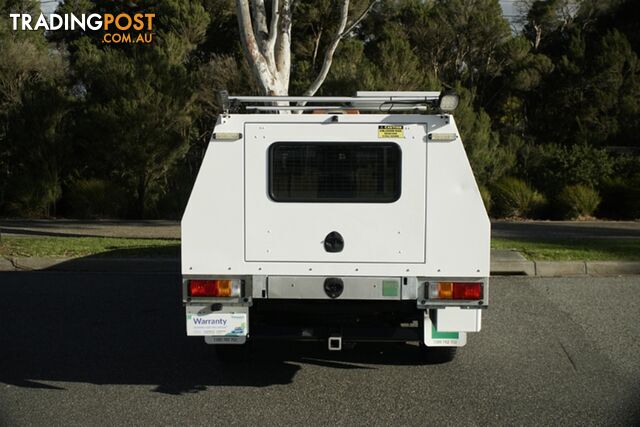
[187, 307, 248, 336]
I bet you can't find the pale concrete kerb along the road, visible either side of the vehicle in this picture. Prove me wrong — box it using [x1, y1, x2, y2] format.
[0, 257, 640, 277]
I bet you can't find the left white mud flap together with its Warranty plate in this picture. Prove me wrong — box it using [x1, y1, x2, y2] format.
[186, 305, 249, 344]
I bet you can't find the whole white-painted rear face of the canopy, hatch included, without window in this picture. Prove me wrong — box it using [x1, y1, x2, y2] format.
[182, 114, 490, 278]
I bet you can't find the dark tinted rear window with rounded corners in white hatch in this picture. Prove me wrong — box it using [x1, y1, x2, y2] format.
[269, 142, 402, 203]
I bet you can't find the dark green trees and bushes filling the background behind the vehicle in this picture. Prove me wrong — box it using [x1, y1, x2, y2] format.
[0, 0, 640, 218]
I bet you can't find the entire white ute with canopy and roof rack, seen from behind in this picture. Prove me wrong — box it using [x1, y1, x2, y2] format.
[182, 92, 490, 360]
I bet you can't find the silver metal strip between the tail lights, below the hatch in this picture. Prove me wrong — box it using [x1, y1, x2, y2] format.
[267, 276, 402, 300]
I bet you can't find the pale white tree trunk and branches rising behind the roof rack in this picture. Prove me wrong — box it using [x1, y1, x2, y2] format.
[236, 0, 379, 96]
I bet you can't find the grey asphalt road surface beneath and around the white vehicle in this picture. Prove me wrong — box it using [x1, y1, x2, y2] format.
[0, 272, 640, 426]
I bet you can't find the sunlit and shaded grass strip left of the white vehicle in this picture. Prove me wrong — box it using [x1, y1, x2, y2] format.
[0, 236, 180, 258]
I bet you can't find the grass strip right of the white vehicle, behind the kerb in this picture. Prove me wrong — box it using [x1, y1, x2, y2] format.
[491, 239, 640, 261]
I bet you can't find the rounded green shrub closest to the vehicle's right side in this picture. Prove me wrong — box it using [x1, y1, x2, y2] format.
[492, 177, 546, 218]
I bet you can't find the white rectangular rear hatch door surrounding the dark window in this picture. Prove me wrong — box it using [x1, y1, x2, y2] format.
[244, 123, 428, 263]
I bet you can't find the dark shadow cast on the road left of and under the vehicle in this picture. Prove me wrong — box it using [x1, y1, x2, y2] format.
[0, 272, 436, 395]
